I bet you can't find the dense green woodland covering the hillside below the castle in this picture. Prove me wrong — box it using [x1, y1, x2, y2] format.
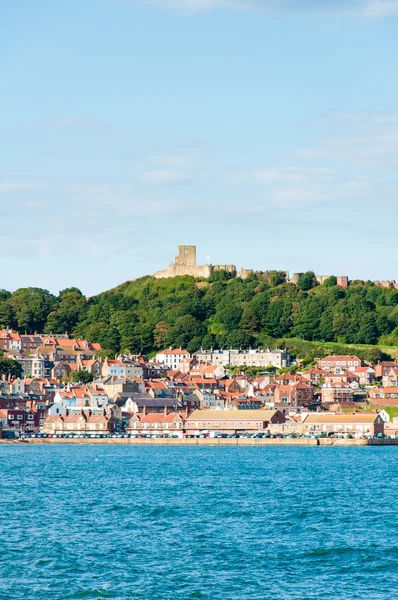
[0, 271, 398, 355]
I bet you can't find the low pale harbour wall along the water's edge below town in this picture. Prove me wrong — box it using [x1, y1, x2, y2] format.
[4, 438, 398, 447]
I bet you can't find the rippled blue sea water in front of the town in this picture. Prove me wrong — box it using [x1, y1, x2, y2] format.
[0, 444, 398, 600]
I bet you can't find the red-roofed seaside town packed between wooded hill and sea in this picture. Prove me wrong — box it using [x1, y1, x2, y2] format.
[0, 330, 398, 439]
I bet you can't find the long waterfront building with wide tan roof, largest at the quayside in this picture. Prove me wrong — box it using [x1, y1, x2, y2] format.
[185, 409, 285, 433]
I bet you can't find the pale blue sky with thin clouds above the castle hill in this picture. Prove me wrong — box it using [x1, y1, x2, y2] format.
[0, 0, 398, 295]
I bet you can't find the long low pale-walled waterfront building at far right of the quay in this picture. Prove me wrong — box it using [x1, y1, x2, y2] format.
[303, 413, 384, 437]
